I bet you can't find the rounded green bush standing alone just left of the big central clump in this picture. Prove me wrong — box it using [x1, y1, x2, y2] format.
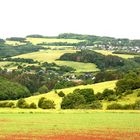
[38, 97, 55, 109]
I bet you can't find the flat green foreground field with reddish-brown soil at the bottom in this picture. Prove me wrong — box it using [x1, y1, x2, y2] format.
[0, 110, 140, 140]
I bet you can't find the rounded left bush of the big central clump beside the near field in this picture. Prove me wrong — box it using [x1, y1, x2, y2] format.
[61, 93, 86, 109]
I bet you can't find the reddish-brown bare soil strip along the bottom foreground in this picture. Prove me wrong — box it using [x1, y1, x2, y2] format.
[0, 130, 140, 140]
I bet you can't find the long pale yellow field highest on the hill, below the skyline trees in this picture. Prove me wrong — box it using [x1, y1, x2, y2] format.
[26, 37, 84, 45]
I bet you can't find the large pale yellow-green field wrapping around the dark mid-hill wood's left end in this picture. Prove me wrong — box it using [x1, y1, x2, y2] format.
[15, 50, 99, 72]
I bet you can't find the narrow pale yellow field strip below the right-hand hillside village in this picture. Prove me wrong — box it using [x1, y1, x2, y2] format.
[95, 50, 136, 59]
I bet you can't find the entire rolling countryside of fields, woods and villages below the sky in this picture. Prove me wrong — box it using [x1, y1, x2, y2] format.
[0, 33, 140, 140]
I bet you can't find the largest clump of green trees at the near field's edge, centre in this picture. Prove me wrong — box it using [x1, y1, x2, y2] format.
[61, 89, 102, 109]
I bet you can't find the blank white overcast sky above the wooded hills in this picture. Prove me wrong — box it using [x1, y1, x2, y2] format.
[0, 0, 140, 39]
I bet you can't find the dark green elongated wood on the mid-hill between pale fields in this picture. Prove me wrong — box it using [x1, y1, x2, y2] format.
[60, 50, 125, 69]
